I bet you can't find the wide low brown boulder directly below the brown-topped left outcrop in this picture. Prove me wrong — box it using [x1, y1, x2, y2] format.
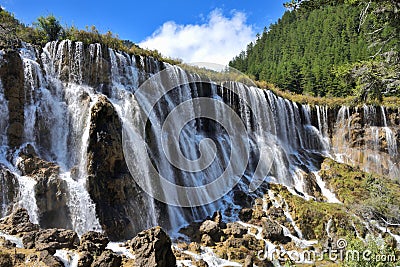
[35, 229, 79, 254]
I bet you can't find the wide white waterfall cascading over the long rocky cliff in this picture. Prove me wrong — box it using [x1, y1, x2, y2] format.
[0, 40, 399, 242]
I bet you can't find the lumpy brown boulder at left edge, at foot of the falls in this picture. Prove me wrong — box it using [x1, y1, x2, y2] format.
[0, 208, 39, 235]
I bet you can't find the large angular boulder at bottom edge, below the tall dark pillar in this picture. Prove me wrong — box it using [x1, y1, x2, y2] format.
[130, 227, 176, 267]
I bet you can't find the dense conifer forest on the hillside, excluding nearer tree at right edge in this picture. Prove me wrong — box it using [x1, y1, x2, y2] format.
[230, 1, 373, 96]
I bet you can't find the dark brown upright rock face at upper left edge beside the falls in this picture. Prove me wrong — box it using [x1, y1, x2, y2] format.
[0, 51, 25, 148]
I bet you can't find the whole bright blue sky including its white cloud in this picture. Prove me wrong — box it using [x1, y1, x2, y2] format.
[0, 0, 285, 64]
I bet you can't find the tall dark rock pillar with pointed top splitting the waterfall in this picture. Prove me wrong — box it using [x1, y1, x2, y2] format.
[87, 96, 151, 240]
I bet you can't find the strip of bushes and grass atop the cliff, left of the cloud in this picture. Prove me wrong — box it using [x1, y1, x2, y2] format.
[0, 8, 181, 64]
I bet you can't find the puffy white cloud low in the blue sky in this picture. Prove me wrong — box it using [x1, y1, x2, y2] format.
[139, 9, 255, 65]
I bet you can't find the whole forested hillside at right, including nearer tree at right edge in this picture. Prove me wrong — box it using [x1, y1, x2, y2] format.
[230, 0, 400, 102]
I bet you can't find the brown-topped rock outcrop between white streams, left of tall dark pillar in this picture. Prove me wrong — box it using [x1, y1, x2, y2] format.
[17, 145, 72, 228]
